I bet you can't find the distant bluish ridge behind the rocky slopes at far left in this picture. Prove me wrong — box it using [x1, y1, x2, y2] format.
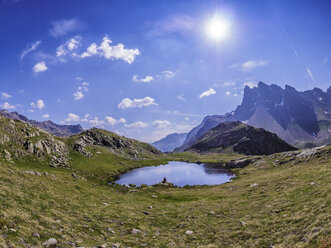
[0, 109, 84, 137]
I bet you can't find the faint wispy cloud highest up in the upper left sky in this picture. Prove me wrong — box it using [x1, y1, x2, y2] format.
[49, 19, 85, 38]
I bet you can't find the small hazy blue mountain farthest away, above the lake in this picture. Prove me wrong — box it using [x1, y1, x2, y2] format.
[151, 133, 187, 152]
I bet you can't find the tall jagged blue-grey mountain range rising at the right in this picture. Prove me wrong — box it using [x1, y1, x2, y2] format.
[175, 82, 331, 151]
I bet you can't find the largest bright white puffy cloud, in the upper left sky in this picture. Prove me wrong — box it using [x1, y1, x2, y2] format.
[80, 36, 140, 64]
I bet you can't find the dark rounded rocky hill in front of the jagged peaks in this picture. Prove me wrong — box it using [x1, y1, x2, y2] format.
[186, 121, 297, 155]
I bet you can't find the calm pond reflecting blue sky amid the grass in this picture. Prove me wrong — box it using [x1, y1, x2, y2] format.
[116, 161, 235, 187]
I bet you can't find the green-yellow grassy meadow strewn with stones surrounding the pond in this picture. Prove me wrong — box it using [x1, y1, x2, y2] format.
[0, 147, 331, 247]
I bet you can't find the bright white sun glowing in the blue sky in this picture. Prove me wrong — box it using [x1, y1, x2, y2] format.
[206, 16, 230, 41]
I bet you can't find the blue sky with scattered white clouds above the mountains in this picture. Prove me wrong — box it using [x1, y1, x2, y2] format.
[0, 0, 331, 142]
